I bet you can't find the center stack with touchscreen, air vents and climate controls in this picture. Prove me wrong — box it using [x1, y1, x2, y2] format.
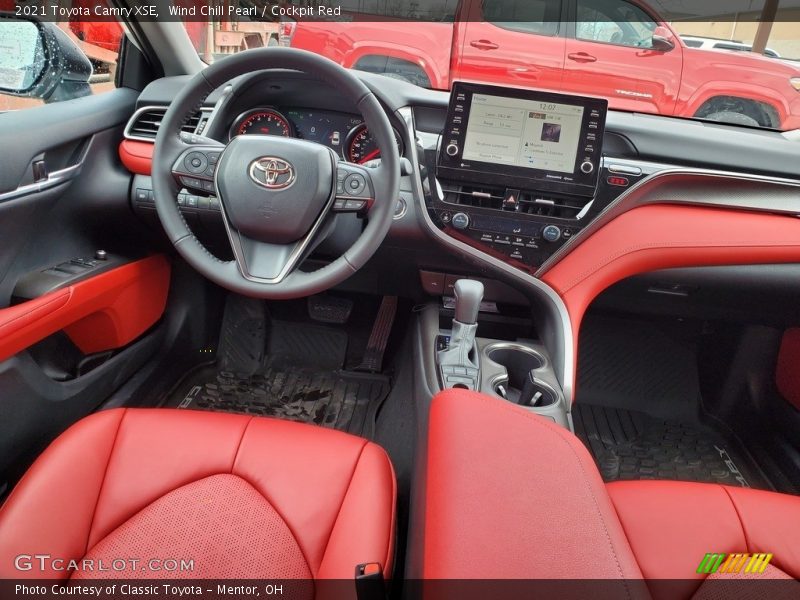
[422, 82, 636, 273]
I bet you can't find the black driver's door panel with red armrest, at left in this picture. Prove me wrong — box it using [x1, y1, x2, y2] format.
[0, 88, 169, 482]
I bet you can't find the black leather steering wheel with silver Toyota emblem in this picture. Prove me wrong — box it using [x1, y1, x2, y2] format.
[152, 47, 400, 299]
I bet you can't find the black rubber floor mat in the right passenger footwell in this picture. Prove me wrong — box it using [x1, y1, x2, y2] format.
[572, 402, 771, 489]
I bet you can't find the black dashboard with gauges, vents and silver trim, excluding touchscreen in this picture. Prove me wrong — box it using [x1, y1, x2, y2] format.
[119, 67, 798, 282]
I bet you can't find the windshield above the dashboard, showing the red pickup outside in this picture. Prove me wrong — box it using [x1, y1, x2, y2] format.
[181, 0, 800, 131]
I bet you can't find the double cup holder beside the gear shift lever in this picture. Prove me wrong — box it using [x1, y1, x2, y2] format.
[486, 345, 558, 408]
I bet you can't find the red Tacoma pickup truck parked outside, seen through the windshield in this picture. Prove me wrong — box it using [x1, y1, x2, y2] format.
[280, 0, 800, 130]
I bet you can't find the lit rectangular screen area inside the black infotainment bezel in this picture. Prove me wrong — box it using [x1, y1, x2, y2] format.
[462, 93, 585, 173]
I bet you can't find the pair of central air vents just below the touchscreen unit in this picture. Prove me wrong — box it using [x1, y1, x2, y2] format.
[442, 185, 586, 219]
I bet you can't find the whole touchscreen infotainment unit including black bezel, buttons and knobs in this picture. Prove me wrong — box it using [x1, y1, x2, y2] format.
[438, 82, 607, 194]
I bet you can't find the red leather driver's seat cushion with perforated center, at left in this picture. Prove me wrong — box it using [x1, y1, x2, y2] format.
[0, 409, 395, 580]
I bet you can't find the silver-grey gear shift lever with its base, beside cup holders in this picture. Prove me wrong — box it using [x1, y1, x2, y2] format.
[439, 279, 483, 390]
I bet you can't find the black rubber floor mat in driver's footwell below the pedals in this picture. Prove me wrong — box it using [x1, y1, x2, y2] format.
[167, 361, 390, 437]
